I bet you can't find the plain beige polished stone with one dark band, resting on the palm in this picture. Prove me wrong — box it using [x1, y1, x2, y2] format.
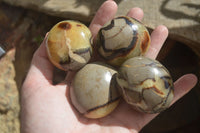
[70, 63, 120, 118]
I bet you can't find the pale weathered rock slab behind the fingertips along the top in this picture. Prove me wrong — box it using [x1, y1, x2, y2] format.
[3, 0, 200, 56]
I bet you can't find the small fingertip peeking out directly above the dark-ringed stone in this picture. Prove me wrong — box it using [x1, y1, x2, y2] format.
[126, 7, 144, 21]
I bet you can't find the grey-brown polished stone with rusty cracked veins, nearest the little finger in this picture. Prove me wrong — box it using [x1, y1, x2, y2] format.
[117, 57, 174, 113]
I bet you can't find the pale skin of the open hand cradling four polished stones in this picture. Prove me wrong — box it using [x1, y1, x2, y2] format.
[20, 0, 197, 133]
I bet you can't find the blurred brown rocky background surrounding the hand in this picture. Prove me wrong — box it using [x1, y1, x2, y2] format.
[0, 0, 200, 133]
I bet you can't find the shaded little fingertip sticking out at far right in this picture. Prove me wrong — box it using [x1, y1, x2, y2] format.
[172, 74, 197, 104]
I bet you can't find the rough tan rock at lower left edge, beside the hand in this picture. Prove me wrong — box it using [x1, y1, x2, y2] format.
[0, 49, 19, 133]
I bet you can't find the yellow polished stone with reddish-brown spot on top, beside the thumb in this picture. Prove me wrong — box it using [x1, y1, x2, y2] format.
[46, 20, 92, 71]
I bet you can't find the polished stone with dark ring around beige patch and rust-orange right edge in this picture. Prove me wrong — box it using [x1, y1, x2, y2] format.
[97, 16, 150, 66]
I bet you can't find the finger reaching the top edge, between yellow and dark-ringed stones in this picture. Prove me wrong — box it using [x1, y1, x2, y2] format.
[89, 0, 117, 38]
